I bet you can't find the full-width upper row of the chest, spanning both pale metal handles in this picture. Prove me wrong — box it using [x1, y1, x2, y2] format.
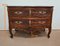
[8, 7, 53, 18]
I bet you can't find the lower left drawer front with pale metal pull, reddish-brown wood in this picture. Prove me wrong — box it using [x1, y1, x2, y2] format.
[10, 20, 29, 28]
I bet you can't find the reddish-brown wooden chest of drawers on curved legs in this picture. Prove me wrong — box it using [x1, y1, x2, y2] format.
[7, 6, 53, 38]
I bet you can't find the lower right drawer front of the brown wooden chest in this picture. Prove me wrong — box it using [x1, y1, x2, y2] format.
[31, 19, 50, 26]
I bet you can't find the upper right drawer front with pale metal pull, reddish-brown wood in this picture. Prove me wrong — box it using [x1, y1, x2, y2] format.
[31, 8, 51, 17]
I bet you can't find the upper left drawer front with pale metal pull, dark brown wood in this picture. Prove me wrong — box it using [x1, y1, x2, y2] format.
[8, 8, 29, 17]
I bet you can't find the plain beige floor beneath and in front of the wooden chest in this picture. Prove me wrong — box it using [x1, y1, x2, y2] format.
[0, 30, 60, 46]
